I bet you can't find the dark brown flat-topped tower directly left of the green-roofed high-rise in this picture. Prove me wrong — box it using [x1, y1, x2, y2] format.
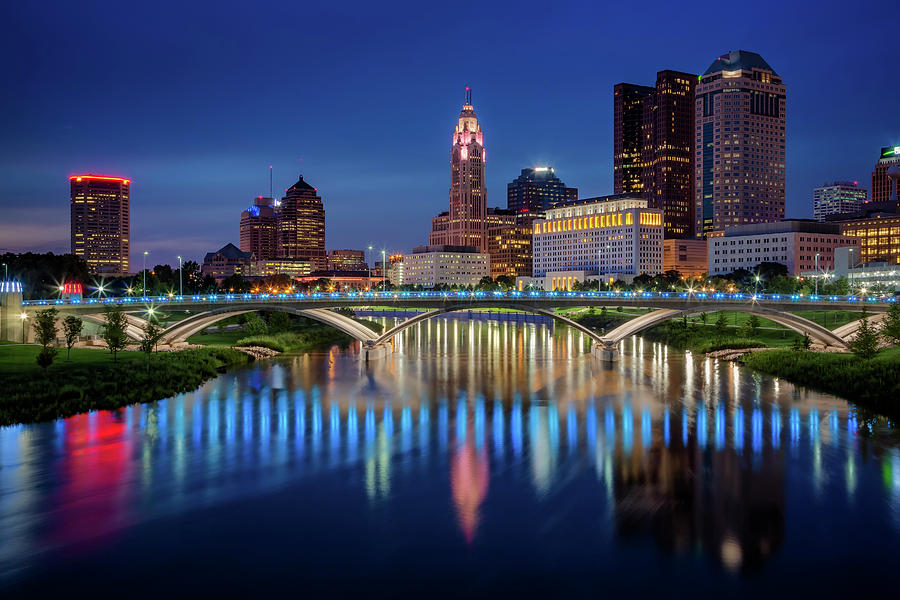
[641, 71, 697, 238]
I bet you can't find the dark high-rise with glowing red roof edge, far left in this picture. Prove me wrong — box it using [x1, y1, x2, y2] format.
[69, 175, 131, 276]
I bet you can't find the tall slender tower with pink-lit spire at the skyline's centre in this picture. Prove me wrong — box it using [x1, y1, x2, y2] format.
[448, 87, 487, 252]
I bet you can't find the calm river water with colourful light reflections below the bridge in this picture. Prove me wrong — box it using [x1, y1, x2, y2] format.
[0, 319, 900, 597]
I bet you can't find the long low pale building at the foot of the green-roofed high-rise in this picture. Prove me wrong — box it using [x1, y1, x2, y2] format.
[707, 220, 859, 277]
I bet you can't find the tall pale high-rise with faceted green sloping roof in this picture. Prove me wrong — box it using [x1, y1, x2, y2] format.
[694, 50, 785, 237]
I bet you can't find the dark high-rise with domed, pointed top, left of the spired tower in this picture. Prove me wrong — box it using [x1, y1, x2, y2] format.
[278, 175, 328, 270]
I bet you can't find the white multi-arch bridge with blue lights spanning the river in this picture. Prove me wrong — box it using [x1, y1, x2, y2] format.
[0, 292, 896, 360]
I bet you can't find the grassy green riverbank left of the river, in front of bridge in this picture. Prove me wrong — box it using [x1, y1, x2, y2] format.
[0, 346, 253, 426]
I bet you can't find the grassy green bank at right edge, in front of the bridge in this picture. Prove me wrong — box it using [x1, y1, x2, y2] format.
[744, 347, 900, 418]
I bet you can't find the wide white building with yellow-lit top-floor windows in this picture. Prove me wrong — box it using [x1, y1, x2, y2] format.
[532, 195, 663, 280]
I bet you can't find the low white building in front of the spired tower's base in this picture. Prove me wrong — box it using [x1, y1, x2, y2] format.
[403, 245, 490, 287]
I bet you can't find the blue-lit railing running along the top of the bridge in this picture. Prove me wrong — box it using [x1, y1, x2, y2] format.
[22, 291, 898, 308]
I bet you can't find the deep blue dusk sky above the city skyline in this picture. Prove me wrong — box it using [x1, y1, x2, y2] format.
[0, 0, 900, 269]
